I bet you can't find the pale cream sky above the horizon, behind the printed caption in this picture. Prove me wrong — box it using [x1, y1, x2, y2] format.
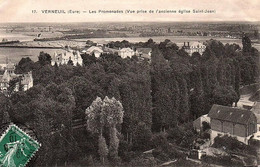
[0, 0, 260, 22]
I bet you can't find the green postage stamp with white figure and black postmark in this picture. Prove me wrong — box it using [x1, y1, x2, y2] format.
[0, 124, 40, 167]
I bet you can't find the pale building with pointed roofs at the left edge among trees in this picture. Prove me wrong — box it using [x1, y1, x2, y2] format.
[0, 63, 33, 92]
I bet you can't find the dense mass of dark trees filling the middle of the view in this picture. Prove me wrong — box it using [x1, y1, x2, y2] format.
[0, 36, 259, 165]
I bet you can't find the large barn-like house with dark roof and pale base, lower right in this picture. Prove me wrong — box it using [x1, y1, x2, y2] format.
[208, 104, 257, 144]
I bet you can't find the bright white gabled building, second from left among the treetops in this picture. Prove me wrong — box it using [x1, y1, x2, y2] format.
[51, 50, 83, 66]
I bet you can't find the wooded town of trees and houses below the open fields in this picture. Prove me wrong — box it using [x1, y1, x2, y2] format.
[0, 24, 260, 166]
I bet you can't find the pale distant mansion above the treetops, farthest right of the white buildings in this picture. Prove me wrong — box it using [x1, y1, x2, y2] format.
[183, 42, 206, 56]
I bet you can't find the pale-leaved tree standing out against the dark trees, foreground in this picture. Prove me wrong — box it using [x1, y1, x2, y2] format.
[86, 96, 124, 161]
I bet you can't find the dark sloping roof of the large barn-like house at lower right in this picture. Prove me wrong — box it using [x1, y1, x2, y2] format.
[208, 104, 254, 124]
